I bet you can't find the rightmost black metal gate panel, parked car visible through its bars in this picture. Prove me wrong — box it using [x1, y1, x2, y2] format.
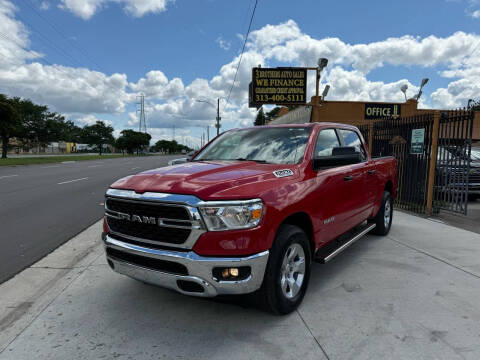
[433, 110, 474, 214]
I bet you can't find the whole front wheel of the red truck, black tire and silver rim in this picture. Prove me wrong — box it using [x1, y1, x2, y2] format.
[256, 224, 312, 315]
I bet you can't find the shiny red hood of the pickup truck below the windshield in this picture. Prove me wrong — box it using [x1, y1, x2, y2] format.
[111, 161, 299, 200]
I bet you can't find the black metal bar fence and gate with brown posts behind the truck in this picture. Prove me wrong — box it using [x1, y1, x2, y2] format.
[358, 110, 474, 214]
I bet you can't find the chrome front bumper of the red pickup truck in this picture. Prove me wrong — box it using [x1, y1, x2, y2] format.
[104, 235, 269, 297]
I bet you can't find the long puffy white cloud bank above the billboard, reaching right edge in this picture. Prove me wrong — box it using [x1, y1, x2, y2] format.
[248, 20, 480, 74]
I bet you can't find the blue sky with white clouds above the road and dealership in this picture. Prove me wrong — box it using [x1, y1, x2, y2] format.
[0, 0, 480, 144]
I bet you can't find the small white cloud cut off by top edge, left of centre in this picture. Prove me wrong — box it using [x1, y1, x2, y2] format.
[59, 0, 174, 20]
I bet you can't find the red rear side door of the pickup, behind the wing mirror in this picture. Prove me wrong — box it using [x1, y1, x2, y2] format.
[337, 129, 371, 229]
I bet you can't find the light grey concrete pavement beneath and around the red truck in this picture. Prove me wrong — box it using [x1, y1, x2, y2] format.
[0, 212, 480, 360]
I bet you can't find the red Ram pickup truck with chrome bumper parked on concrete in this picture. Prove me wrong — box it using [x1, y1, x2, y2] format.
[103, 123, 397, 314]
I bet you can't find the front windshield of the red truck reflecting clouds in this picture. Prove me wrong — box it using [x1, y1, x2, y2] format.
[193, 127, 310, 164]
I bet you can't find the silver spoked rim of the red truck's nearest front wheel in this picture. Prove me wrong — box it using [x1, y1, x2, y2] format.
[280, 243, 305, 299]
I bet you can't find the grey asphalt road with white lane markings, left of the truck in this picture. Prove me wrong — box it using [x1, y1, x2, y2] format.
[0, 155, 179, 283]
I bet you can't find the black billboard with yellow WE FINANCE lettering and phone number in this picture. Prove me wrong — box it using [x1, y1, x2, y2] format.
[250, 68, 307, 105]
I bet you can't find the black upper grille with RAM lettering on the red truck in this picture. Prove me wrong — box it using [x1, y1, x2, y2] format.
[105, 198, 198, 246]
